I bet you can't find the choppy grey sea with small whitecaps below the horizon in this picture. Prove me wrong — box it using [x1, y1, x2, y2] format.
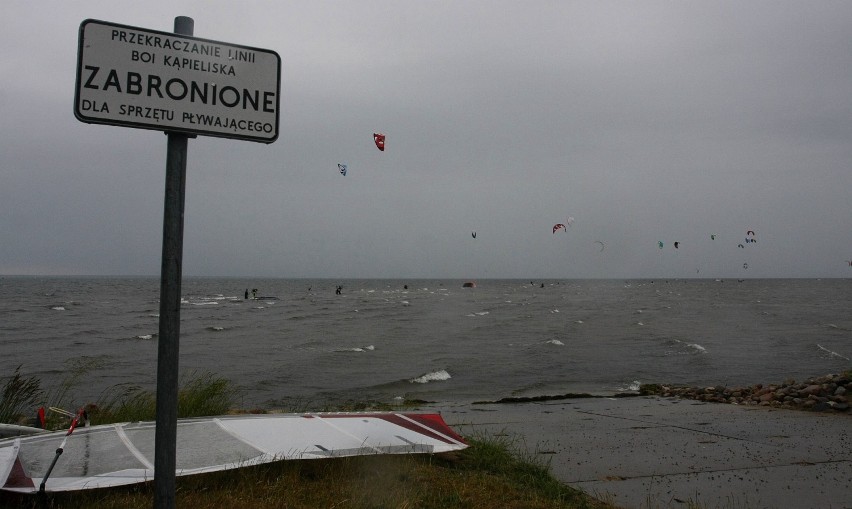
[0, 276, 852, 411]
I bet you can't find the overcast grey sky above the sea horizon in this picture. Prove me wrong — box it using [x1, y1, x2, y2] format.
[0, 0, 852, 279]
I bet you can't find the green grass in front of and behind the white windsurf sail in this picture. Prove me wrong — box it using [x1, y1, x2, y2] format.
[0, 371, 615, 509]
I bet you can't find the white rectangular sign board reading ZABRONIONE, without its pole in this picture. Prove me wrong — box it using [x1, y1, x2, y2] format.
[74, 19, 281, 143]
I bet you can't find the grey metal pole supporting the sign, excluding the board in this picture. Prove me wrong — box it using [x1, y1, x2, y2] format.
[154, 16, 195, 509]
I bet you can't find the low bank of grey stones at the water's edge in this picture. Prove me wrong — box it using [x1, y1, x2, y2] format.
[639, 373, 852, 413]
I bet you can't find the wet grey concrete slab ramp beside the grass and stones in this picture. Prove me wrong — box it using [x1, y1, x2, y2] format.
[439, 396, 852, 509]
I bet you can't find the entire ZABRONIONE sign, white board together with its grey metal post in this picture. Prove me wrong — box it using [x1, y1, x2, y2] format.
[74, 16, 281, 508]
